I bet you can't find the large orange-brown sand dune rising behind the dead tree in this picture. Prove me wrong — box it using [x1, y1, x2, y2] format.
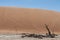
[0, 7, 60, 33]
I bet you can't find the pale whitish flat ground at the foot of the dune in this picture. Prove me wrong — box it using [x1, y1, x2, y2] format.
[0, 34, 60, 40]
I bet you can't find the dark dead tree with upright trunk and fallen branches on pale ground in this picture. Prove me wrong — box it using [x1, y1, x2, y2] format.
[21, 24, 58, 39]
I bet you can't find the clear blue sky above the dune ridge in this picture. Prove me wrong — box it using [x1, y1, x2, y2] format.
[0, 0, 60, 12]
